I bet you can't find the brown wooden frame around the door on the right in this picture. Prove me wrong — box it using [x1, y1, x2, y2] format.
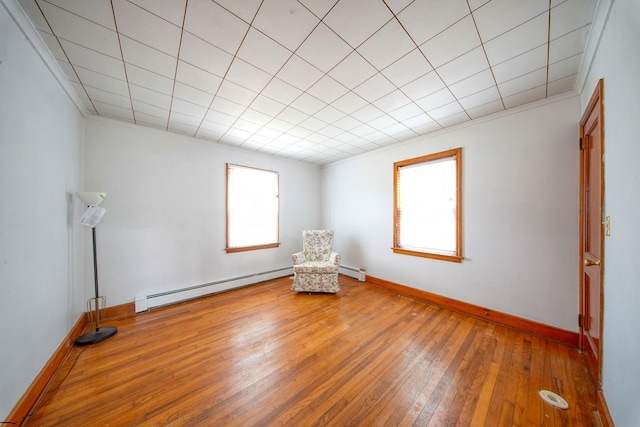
[578, 79, 605, 390]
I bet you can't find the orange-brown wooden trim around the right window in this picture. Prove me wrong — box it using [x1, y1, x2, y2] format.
[391, 148, 464, 263]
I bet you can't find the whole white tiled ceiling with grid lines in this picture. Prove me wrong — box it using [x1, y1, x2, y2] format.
[20, 0, 597, 165]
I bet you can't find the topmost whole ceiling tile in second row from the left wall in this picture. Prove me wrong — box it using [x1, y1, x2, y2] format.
[41, 2, 120, 58]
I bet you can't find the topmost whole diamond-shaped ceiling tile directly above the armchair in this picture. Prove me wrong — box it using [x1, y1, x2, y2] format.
[296, 22, 353, 73]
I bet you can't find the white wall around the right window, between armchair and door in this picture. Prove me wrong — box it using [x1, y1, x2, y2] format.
[322, 96, 579, 331]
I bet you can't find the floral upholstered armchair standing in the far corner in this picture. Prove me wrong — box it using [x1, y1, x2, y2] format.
[291, 230, 340, 293]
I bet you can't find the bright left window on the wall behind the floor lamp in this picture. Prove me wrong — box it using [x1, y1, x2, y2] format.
[226, 163, 280, 252]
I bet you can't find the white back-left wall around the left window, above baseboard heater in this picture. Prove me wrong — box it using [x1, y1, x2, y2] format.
[85, 119, 320, 306]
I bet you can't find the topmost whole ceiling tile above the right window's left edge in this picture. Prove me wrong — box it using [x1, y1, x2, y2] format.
[358, 19, 416, 70]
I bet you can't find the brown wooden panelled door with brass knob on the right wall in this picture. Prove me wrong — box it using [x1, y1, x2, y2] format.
[580, 80, 605, 388]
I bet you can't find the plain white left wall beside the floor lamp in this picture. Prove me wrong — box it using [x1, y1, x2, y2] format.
[0, 3, 84, 420]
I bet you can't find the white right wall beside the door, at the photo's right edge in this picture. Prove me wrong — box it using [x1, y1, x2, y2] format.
[582, 0, 640, 427]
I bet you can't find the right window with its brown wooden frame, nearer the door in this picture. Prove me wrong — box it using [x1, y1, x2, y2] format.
[393, 148, 462, 262]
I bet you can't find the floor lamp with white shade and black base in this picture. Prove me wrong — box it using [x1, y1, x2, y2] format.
[76, 192, 118, 345]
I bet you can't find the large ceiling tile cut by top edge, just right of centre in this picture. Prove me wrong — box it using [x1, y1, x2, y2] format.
[324, 0, 393, 49]
